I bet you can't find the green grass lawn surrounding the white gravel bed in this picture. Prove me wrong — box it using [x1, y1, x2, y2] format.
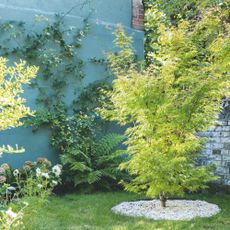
[21, 192, 230, 230]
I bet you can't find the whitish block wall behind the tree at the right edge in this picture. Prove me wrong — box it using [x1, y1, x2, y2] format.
[201, 99, 230, 185]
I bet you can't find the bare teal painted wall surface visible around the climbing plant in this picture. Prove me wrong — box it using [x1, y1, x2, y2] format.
[0, 0, 144, 167]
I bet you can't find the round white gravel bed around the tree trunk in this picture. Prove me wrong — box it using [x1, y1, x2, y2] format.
[112, 200, 220, 220]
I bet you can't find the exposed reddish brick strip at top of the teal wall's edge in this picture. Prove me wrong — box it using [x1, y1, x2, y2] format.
[132, 0, 145, 30]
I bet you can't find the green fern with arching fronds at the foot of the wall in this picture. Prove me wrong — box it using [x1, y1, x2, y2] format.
[61, 133, 127, 191]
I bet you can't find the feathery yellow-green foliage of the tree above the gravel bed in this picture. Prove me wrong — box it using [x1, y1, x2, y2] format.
[101, 3, 230, 197]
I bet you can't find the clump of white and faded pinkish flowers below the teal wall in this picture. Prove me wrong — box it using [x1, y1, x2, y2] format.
[0, 158, 62, 205]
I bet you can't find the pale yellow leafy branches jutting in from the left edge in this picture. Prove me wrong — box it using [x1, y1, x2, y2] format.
[0, 57, 38, 153]
